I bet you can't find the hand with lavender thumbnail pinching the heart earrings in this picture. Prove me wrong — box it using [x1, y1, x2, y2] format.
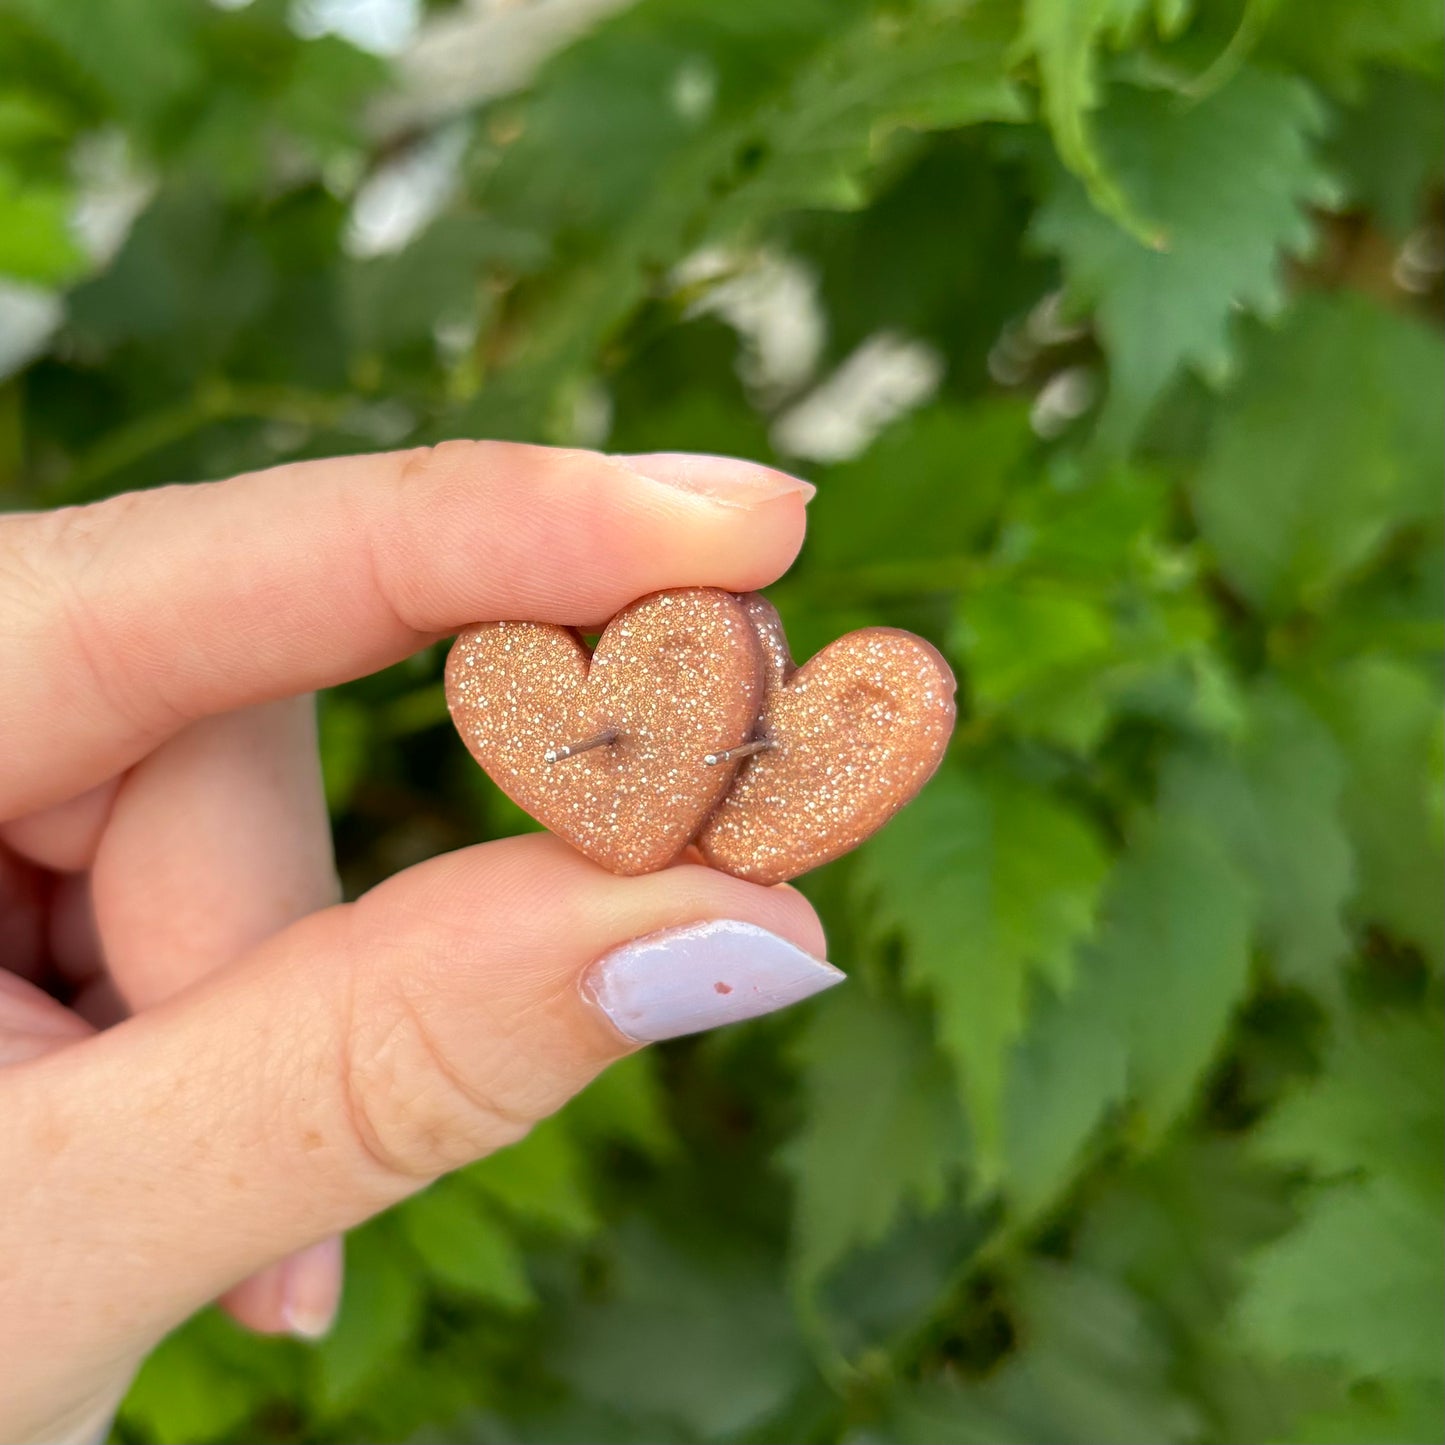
[0, 442, 840, 1441]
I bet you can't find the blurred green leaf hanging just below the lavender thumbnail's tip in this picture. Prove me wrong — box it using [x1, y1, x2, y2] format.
[783, 977, 965, 1289]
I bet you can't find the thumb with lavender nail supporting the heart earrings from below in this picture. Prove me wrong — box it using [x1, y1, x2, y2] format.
[0, 835, 842, 1435]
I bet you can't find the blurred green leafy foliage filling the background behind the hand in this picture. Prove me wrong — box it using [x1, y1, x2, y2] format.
[0, 0, 1445, 1445]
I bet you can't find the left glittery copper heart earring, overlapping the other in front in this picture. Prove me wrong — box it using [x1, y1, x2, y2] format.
[447, 587, 763, 874]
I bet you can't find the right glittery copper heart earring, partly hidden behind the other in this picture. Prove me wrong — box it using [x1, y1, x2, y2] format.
[698, 594, 957, 883]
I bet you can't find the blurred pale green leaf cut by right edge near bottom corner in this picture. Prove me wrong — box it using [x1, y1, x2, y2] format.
[1238, 1179, 1445, 1380]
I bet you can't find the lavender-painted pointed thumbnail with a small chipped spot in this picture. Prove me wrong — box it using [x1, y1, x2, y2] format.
[582, 919, 845, 1043]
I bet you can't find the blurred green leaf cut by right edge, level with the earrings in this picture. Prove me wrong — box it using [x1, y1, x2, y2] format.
[1305, 657, 1445, 968]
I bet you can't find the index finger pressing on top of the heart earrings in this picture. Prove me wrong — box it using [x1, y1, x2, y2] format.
[0, 441, 811, 818]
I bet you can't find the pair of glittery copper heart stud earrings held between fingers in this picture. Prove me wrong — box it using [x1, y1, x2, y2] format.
[447, 587, 955, 883]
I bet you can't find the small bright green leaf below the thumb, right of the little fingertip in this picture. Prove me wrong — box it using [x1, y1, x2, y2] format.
[397, 1179, 536, 1309]
